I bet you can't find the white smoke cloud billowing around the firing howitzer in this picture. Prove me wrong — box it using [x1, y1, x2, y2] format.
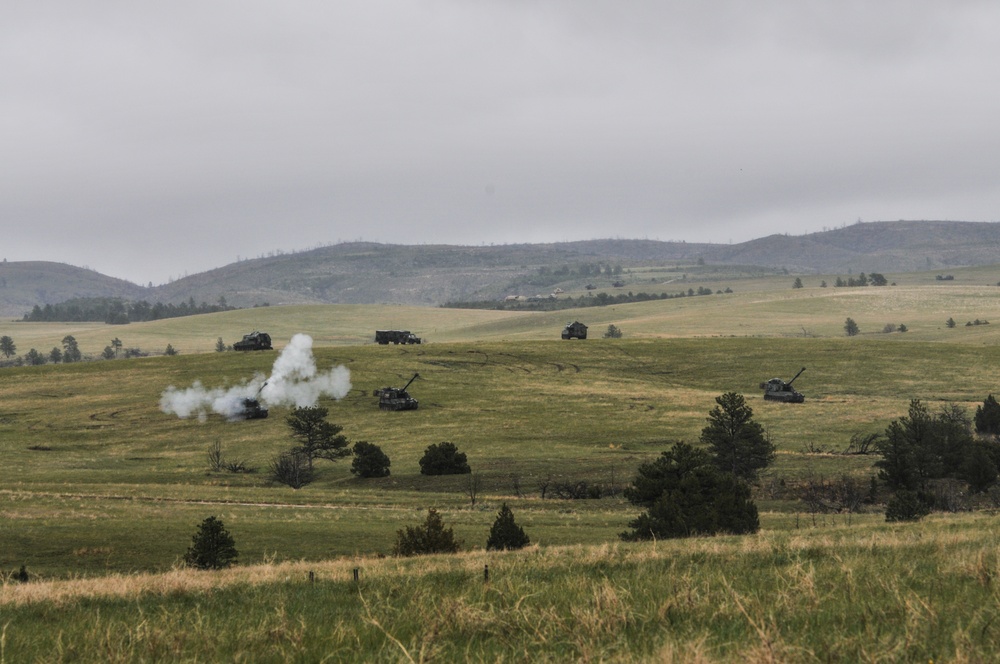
[160, 334, 351, 421]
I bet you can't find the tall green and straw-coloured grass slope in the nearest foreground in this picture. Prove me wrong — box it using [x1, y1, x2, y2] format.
[0, 514, 1000, 662]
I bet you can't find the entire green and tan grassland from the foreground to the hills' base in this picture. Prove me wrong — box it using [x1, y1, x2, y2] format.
[0, 269, 1000, 662]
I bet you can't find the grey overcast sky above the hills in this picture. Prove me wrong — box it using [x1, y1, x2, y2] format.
[0, 0, 1000, 284]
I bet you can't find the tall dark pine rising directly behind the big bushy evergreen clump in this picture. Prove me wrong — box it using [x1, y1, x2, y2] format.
[701, 392, 774, 482]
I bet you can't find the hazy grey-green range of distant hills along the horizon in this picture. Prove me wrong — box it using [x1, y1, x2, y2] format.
[0, 221, 1000, 317]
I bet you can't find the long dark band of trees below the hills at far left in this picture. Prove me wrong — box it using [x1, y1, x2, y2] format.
[22, 297, 238, 325]
